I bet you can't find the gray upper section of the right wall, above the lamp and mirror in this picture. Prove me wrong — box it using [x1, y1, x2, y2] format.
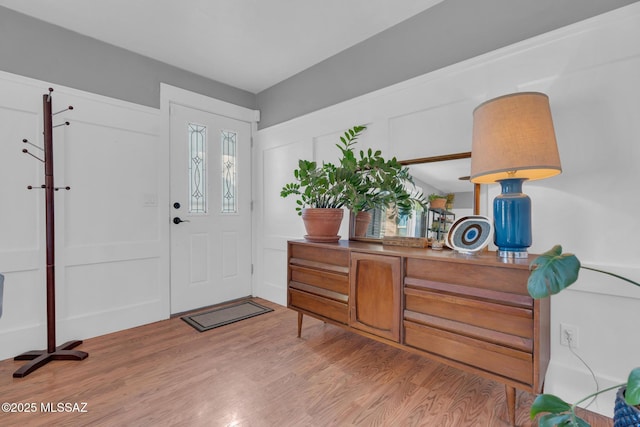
[258, 0, 637, 129]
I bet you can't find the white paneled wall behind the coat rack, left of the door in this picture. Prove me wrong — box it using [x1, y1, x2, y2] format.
[0, 72, 169, 359]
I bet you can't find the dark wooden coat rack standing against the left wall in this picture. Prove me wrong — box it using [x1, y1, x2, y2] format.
[13, 88, 89, 378]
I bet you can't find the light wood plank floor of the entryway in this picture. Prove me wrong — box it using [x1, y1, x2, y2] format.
[0, 299, 613, 427]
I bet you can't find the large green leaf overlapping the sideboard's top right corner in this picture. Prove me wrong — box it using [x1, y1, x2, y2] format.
[527, 245, 580, 299]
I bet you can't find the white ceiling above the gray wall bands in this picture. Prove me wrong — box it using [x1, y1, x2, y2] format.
[0, 0, 443, 93]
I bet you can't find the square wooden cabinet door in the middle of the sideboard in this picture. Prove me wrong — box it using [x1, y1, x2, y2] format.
[349, 252, 402, 342]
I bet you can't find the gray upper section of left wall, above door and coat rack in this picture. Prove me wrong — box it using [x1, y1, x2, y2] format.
[0, 7, 257, 109]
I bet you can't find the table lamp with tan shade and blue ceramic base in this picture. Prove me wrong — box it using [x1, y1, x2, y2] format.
[471, 92, 562, 258]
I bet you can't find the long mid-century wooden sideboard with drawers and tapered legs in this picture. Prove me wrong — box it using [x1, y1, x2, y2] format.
[287, 241, 549, 425]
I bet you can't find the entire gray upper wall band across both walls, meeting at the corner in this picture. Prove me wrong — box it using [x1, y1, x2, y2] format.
[0, 0, 638, 125]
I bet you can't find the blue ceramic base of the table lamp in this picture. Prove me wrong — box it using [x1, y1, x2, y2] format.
[493, 178, 531, 258]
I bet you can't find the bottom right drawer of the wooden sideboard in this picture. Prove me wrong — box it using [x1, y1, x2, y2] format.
[404, 320, 533, 386]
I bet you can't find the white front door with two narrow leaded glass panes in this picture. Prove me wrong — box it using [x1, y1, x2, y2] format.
[170, 104, 251, 313]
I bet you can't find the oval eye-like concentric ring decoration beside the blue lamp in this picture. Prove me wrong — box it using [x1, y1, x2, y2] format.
[445, 215, 493, 254]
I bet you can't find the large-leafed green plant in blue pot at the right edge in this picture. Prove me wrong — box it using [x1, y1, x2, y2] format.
[527, 245, 640, 427]
